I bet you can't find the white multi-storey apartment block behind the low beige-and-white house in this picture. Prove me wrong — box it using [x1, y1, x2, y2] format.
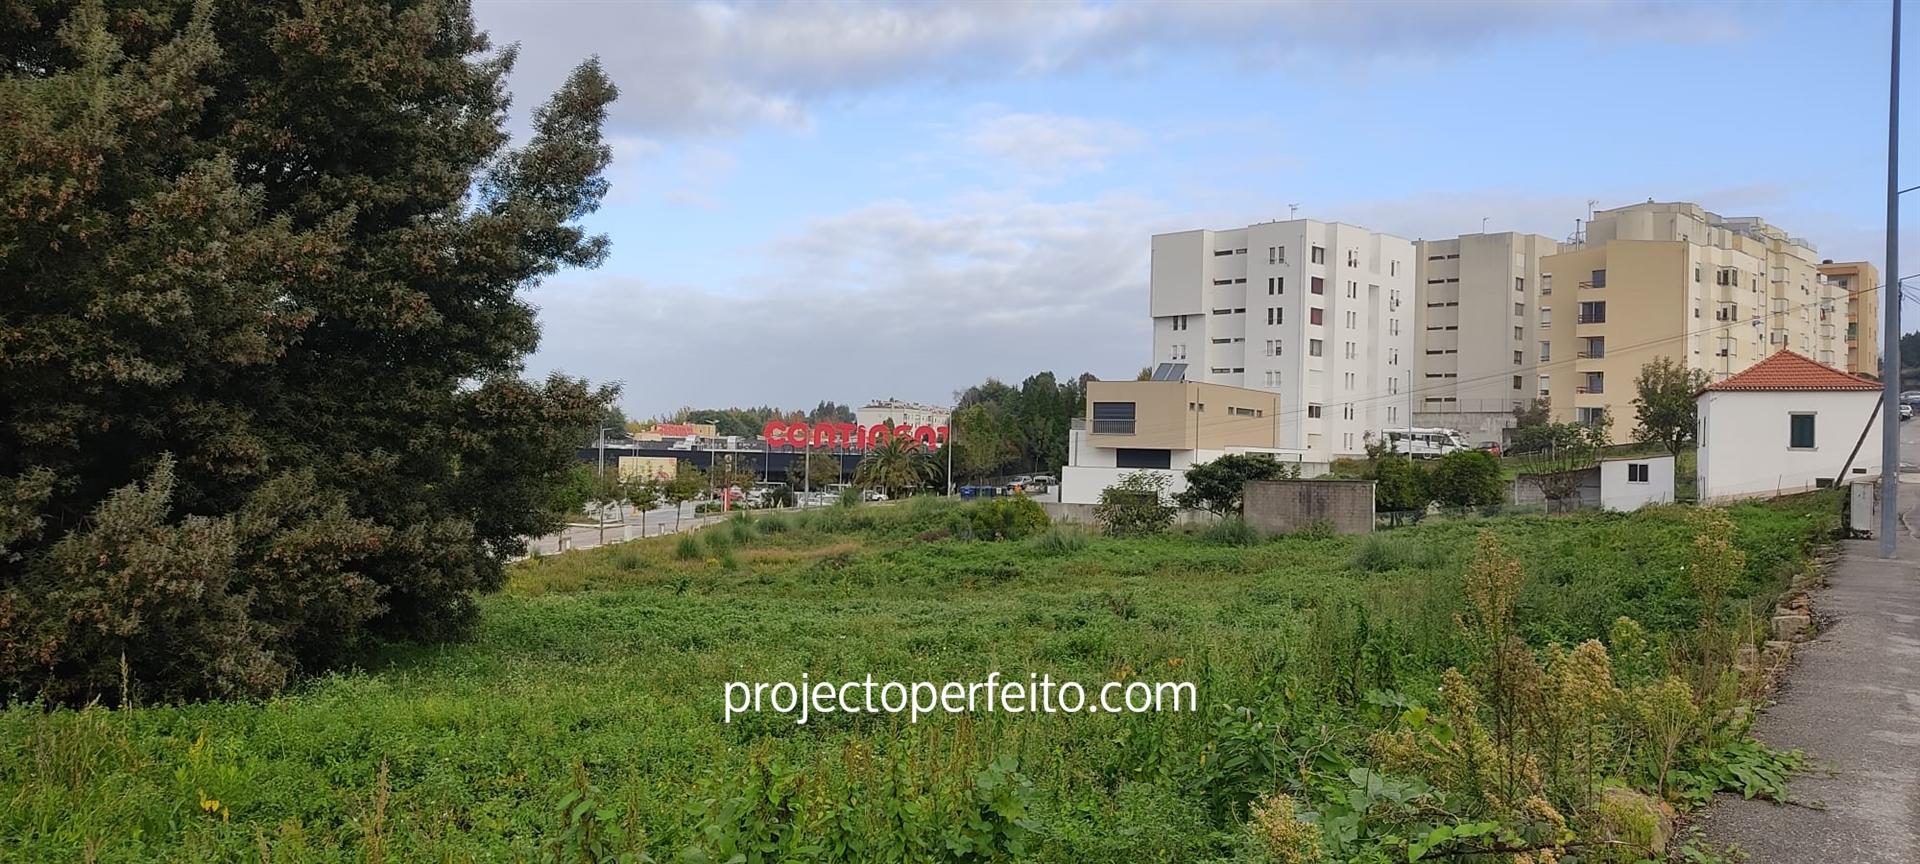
[1150, 219, 1417, 461]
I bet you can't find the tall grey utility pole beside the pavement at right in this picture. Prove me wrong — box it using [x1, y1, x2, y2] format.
[1880, 0, 1903, 559]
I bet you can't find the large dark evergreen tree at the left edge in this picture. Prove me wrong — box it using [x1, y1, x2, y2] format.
[0, 0, 614, 701]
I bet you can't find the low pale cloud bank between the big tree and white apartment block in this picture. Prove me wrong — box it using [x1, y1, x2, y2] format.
[530, 196, 1187, 415]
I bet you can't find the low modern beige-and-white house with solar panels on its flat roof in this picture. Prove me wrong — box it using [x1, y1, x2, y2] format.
[1060, 378, 1327, 505]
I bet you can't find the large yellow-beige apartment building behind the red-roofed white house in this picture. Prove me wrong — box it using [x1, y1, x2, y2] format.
[1534, 202, 1847, 432]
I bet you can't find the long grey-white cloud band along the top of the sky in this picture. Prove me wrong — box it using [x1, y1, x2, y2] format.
[474, 0, 1741, 134]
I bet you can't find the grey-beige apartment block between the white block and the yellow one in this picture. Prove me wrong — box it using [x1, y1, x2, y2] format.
[1413, 230, 1559, 442]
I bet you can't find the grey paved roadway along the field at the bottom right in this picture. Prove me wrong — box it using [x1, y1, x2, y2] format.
[1705, 420, 1920, 864]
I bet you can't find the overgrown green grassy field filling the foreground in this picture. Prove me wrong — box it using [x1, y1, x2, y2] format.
[0, 497, 1834, 862]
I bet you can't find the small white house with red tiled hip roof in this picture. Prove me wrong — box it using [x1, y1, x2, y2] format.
[1695, 349, 1873, 503]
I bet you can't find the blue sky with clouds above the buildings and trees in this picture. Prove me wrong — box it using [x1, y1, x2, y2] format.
[474, 0, 1920, 417]
